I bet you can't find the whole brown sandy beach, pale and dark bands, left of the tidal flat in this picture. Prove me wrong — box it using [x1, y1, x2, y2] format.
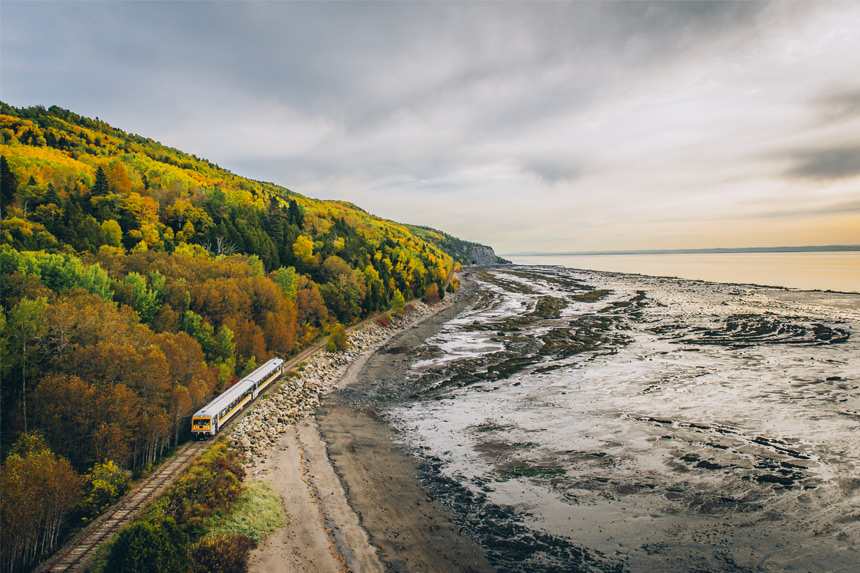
[245, 277, 494, 572]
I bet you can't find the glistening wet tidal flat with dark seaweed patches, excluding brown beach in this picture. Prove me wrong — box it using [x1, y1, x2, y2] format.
[386, 266, 860, 571]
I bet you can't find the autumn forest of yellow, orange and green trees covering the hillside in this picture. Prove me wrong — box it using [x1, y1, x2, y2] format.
[0, 102, 494, 570]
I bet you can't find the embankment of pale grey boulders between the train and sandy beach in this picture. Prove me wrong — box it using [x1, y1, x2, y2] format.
[225, 293, 457, 468]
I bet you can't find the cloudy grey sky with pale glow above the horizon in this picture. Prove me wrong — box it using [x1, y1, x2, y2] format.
[0, 0, 860, 254]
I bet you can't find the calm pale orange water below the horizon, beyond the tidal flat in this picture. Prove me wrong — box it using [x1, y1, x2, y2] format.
[507, 251, 860, 292]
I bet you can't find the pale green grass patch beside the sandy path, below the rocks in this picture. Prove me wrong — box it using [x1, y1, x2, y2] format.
[205, 481, 286, 541]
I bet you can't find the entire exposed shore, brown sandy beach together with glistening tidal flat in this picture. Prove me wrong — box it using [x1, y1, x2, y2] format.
[247, 268, 860, 572]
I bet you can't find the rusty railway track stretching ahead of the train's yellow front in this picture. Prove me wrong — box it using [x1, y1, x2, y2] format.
[36, 442, 207, 572]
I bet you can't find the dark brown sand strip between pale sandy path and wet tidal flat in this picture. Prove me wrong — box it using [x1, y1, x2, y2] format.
[317, 274, 494, 571]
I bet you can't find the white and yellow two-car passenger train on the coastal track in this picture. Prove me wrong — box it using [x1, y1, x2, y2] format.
[191, 358, 285, 439]
